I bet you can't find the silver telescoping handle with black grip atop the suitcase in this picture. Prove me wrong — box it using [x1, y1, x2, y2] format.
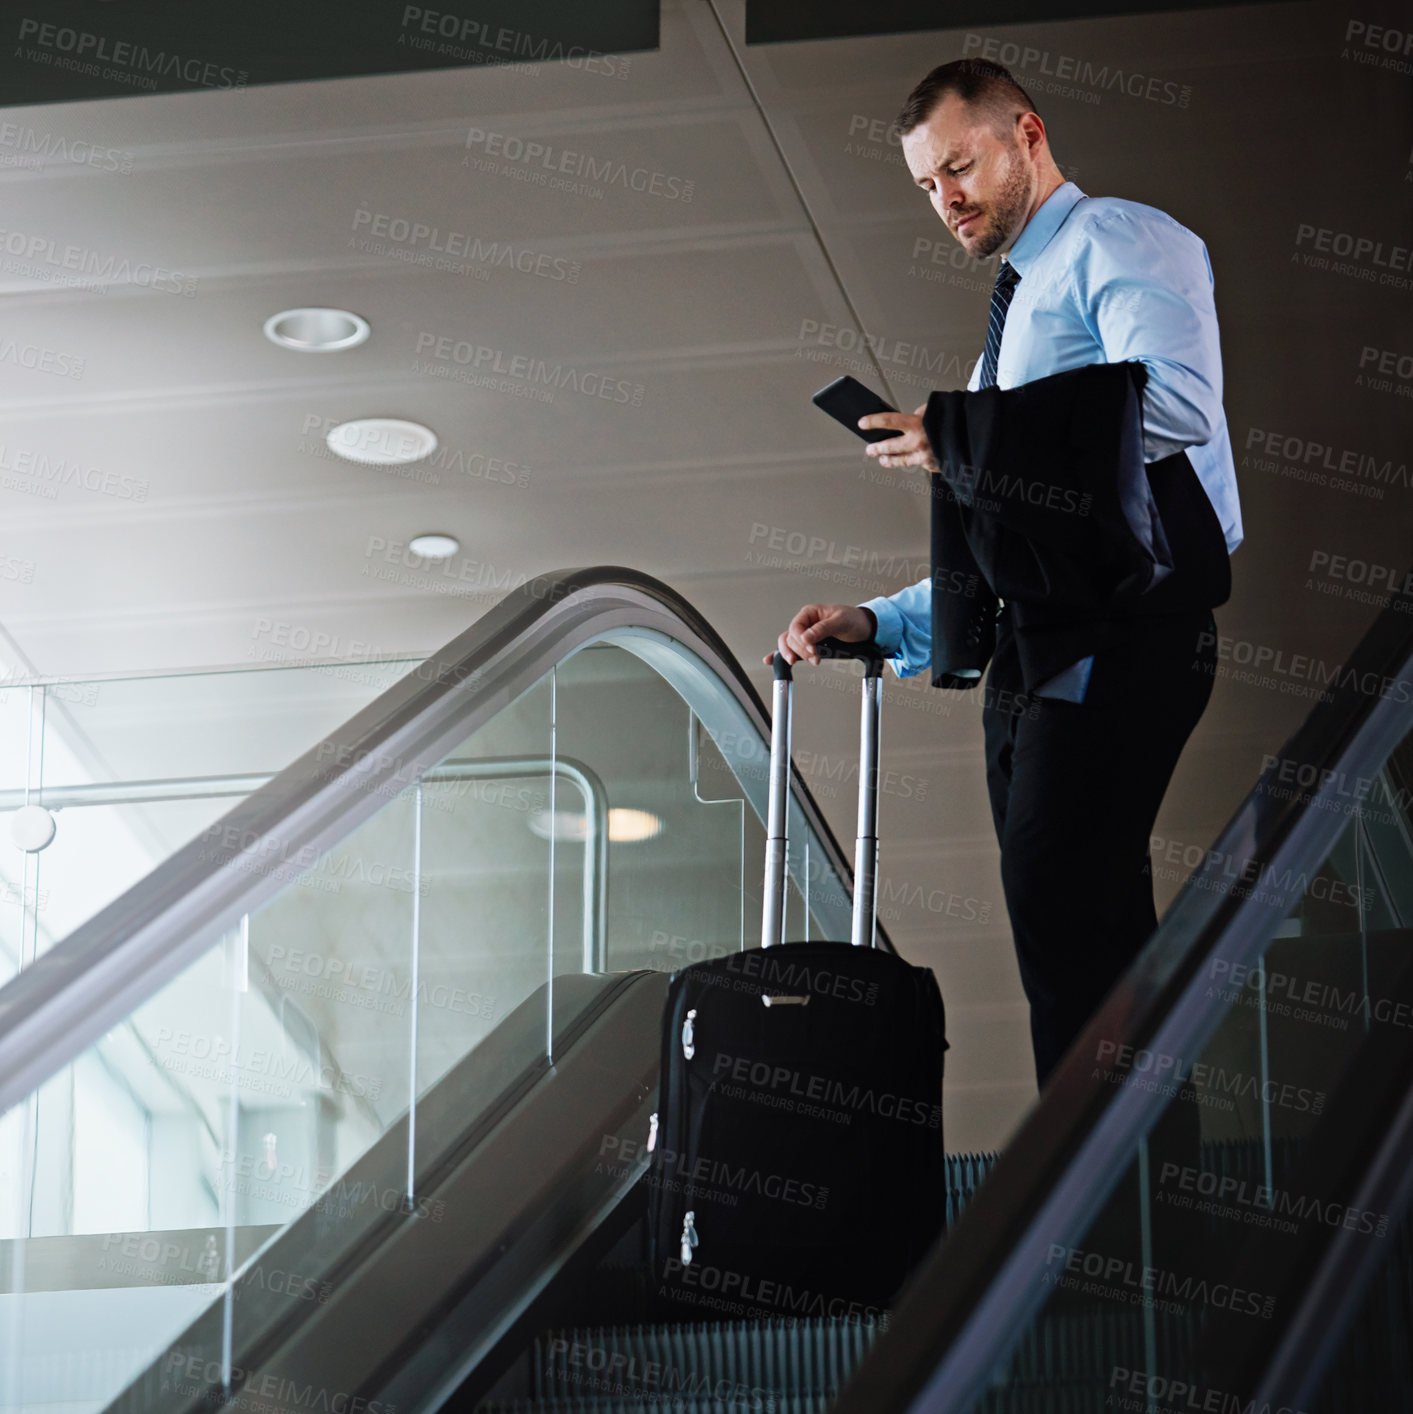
[761, 638, 883, 947]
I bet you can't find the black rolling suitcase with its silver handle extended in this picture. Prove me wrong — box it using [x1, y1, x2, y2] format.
[648, 642, 946, 1319]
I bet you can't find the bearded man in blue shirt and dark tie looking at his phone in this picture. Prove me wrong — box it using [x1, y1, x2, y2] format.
[779, 59, 1242, 1085]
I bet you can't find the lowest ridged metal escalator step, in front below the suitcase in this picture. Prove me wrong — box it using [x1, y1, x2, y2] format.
[533, 1318, 877, 1411]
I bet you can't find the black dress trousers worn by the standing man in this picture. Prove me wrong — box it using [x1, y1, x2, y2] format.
[983, 607, 1216, 1085]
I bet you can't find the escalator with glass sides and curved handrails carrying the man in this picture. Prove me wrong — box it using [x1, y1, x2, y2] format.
[0, 568, 1413, 1414]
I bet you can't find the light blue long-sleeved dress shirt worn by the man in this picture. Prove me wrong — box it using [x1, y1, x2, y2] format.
[863, 181, 1242, 701]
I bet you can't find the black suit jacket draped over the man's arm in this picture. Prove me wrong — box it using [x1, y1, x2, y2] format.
[924, 362, 1231, 690]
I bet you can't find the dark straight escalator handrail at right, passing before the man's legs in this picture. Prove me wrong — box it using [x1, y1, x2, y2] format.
[830, 576, 1413, 1414]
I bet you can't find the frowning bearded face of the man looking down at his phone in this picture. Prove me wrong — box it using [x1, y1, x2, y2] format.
[902, 93, 1040, 259]
